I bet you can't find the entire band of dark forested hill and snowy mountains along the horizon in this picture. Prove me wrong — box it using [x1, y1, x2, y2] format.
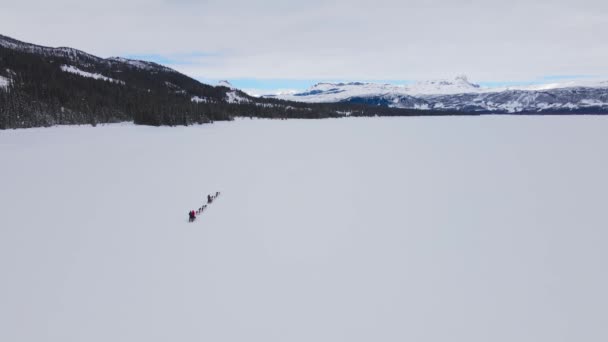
[0, 35, 608, 129]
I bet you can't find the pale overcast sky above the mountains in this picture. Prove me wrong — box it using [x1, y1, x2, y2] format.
[0, 0, 608, 88]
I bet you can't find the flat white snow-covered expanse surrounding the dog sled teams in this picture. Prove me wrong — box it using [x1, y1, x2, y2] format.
[0, 116, 608, 342]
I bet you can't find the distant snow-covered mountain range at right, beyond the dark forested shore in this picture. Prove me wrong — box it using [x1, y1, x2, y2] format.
[264, 76, 608, 114]
